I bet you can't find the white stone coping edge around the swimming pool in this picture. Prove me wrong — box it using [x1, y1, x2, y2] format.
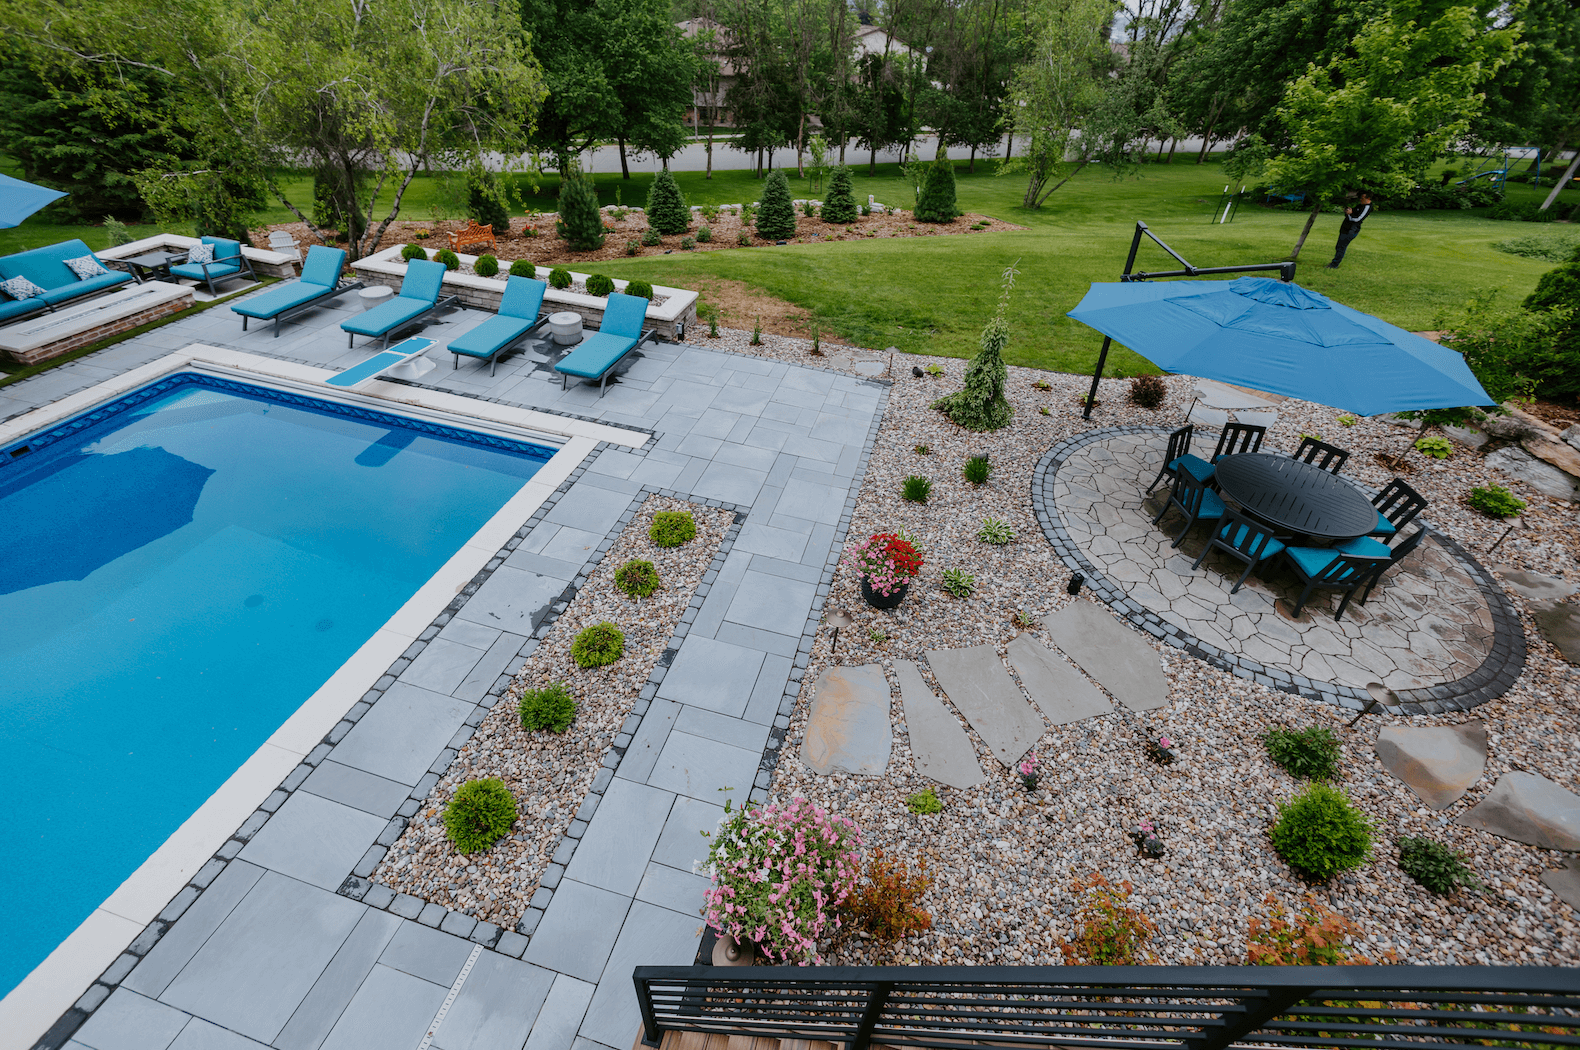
[0, 344, 649, 1050]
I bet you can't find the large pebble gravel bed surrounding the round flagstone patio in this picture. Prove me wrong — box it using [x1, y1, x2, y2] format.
[692, 332, 1580, 965]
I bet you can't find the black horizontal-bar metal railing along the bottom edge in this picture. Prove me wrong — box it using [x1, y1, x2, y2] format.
[634, 966, 1580, 1050]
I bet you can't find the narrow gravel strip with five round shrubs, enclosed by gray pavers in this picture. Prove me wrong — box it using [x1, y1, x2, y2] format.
[373, 496, 735, 928]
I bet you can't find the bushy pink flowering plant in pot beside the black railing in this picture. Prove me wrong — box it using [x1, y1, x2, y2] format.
[703, 799, 861, 966]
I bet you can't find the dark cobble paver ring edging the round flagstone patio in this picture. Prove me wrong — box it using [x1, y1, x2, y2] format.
[1032, 426, 1525, 714]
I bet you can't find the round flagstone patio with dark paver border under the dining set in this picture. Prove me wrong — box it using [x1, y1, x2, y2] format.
[1032, 428, 1525, 711]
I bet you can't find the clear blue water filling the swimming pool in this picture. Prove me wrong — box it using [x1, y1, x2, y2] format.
[0, 374, 553, 995]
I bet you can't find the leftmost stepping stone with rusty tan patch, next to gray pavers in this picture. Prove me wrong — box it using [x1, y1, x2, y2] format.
[801, 663, 894, 777]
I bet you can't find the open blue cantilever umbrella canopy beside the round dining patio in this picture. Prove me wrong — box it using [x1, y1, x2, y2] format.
[1070, 276, 1493, 415]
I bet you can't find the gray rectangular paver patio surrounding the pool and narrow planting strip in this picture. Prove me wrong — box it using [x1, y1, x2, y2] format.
[18, 290, 891, 1050]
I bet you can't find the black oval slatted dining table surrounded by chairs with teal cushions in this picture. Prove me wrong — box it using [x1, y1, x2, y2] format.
[1213, 452, 1378, 540]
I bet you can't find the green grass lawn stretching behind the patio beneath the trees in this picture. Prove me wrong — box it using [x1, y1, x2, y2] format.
[0, 155, 1580, 374]
